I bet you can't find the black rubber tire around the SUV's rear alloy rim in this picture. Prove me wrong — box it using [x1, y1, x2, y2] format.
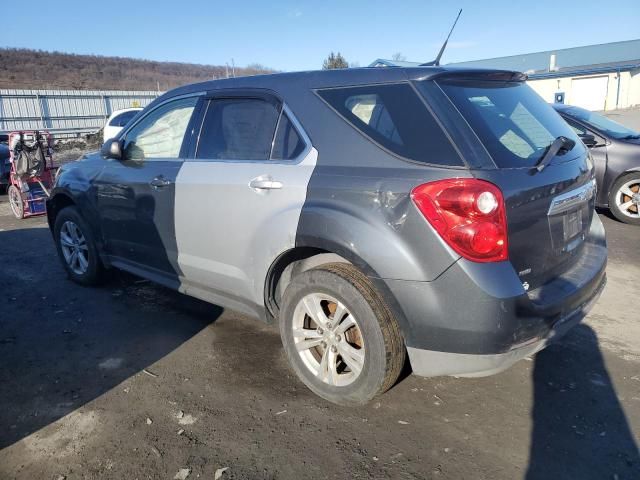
[280, 263, 406, 405]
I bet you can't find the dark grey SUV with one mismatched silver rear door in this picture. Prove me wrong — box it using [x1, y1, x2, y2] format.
[47, 67, 607, 404]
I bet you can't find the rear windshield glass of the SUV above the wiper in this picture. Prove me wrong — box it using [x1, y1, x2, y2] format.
[439, 80, 585, 168]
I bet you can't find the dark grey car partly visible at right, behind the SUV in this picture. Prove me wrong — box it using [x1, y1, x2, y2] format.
[554, 104, 640, 225]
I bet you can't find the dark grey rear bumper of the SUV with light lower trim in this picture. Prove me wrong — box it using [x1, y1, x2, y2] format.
[377, 216, 607, 376]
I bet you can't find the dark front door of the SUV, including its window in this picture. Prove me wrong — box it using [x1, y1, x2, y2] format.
[95, 96, 198, 287]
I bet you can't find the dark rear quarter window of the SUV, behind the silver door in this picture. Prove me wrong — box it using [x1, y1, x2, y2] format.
[318, 83, 462, 166]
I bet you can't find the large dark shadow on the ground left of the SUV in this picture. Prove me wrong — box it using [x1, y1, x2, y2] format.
[0, 228, 222, 449]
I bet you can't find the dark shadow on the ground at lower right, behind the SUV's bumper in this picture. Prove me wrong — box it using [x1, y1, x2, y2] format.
[526, 324, 640, 480]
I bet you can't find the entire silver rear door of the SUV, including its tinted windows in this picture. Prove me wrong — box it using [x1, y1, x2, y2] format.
[176, 92, 317, 314]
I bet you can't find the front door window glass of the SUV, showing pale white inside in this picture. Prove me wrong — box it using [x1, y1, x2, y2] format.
[124, 97, 198, 160]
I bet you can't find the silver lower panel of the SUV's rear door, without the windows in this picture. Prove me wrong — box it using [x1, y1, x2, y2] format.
[175, 148, 318, 309]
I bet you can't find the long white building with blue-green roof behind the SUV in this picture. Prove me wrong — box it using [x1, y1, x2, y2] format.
[370, 39, 640, 110]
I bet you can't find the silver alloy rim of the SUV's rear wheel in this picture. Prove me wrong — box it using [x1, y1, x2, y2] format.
[292, 293, 365, 387]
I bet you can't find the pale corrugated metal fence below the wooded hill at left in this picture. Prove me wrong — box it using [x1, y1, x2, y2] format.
[0, 89, 162, 138]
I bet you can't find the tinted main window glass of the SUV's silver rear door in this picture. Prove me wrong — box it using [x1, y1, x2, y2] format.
[196, 98, 280, 160]
